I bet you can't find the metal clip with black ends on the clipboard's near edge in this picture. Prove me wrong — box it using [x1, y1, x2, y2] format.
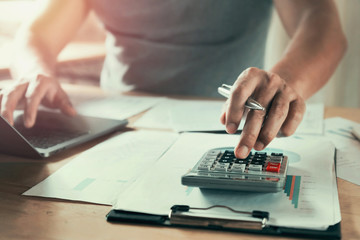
[169, 205, 269, 230]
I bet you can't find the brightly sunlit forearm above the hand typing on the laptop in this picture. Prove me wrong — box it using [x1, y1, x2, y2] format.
[12, 0, 89, 78]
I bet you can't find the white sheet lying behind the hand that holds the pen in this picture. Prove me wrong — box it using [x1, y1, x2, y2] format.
[134, 99, 324, 135]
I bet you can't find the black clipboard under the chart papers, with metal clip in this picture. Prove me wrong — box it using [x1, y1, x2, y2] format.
[106, 205, 341, 239]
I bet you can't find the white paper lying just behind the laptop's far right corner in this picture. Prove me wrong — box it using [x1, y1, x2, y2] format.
[71, 95, 163, 120]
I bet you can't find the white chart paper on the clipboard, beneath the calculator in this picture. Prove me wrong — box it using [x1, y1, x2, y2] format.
[113, 133, 341, 229]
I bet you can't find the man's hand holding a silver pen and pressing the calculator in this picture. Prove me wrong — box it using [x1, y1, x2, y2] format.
[220, 68, 305, 158]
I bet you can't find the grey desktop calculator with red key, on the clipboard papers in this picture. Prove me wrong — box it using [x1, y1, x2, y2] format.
[181, 147, 288, 192]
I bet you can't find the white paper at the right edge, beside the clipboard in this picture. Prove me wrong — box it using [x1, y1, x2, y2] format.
[325, 117, 360, 185]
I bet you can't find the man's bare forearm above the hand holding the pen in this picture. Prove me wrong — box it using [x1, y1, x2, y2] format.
[270, 2, 346, 99]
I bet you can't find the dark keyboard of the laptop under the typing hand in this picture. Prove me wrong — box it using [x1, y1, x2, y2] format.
[17, 127, 87, 148]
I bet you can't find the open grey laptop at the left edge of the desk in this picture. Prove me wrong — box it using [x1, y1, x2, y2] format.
[0, 110, 128, 158]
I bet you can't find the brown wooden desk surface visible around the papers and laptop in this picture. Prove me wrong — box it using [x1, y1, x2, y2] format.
[0, 85, 360, 240]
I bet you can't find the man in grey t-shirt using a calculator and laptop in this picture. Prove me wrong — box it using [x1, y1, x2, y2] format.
[0, 0, 346, 158]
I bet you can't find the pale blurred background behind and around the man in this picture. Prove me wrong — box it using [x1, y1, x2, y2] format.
[0, 0, 360, 108]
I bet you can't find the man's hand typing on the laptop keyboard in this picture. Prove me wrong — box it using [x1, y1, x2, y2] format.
[0, 75, 76, 128]
